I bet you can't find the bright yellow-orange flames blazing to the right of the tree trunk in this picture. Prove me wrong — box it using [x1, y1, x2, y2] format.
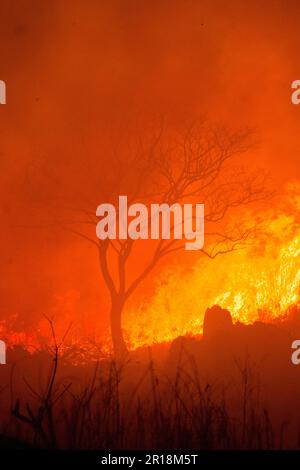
[125, 183, 300, 348]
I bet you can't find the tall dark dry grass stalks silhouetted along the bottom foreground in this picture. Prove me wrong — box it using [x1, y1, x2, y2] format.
[3, 342, 278, 450]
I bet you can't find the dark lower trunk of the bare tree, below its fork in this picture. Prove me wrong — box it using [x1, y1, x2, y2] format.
[110, 297, 128, 359]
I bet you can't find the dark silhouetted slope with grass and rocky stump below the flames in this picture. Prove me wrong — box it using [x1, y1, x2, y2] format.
[0, 307, 299, 450]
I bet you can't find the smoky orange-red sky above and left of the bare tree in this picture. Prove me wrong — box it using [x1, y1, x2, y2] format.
[0, 0, 300, 338]
